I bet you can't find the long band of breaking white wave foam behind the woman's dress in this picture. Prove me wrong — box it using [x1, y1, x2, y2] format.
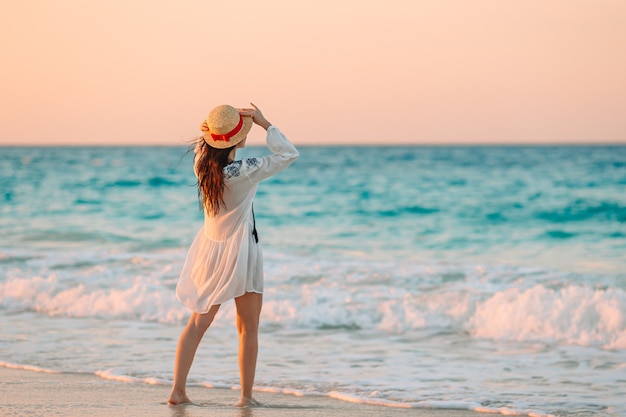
[0, 255, 626, 349]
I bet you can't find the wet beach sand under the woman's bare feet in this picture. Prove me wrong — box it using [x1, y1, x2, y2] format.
[0, 368, 485, 417]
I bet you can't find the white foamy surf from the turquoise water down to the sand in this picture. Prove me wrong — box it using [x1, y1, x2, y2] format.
[0, 249, 626, 417]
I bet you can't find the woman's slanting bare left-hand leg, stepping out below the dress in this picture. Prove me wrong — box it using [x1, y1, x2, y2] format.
[167, 305, 220, 405]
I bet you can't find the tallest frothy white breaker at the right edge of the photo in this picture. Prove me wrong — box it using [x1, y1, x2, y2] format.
[467, 285, 626, 349]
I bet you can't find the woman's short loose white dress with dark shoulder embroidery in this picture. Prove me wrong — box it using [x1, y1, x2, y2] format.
[176, 126, 299, 313]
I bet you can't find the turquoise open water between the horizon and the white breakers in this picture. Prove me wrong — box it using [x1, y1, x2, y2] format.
[0, 147, 626, 275]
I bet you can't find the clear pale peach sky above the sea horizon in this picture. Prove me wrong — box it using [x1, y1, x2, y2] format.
[0, 0, 626, 145]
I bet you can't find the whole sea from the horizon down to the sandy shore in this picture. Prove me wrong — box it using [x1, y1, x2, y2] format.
[0, 145, 626, 416]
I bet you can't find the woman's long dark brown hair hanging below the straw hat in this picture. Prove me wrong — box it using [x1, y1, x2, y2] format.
[194, 138, 234, 216]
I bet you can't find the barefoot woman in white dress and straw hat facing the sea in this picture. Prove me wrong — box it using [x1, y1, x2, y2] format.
[168, 104, 298, 407]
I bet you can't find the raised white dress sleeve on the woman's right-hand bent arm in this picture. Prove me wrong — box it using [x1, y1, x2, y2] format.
[246, 126, 300, 182]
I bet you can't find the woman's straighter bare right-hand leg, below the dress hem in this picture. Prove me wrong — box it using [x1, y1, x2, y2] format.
[235, 292, 263, 407]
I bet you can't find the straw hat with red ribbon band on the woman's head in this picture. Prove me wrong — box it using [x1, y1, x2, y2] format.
[200, 104, 252, 149]
